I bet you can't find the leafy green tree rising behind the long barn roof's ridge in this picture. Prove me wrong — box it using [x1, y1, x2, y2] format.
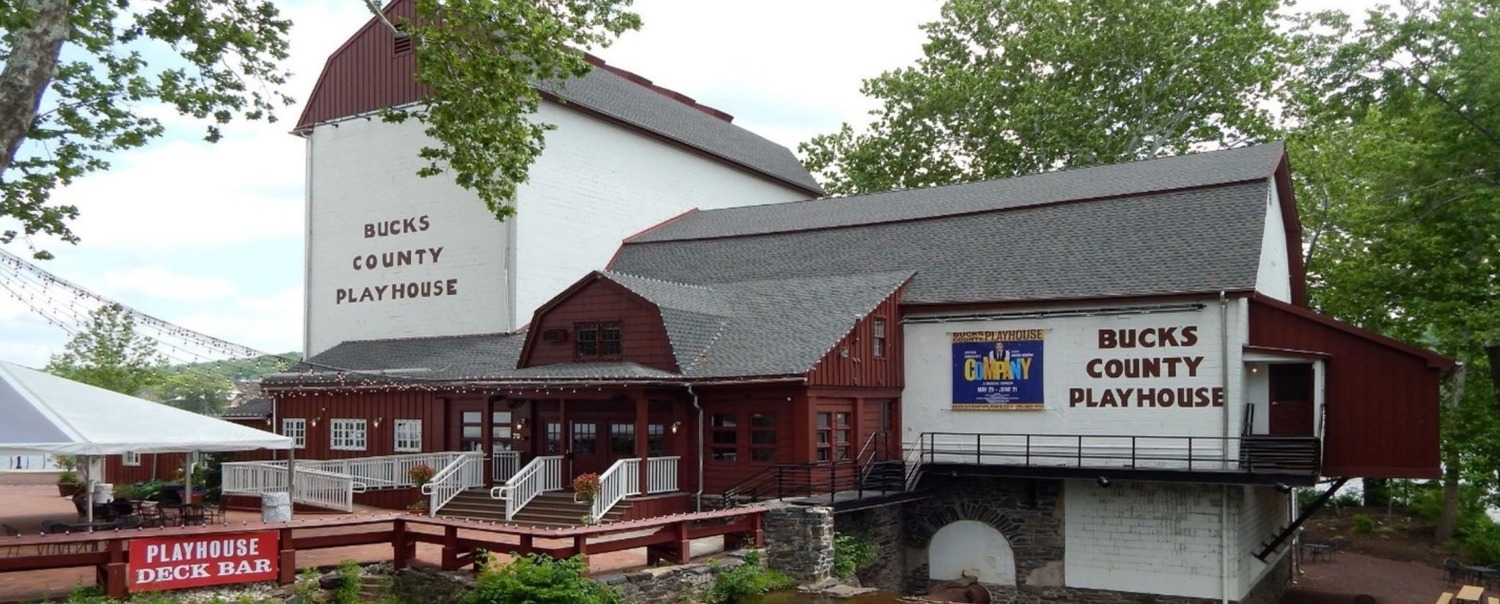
[800, 0, 1287, 193]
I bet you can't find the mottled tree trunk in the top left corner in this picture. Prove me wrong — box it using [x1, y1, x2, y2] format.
[0, 0, 69, 174]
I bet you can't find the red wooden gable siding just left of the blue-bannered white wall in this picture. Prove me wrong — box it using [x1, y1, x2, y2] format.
[807, 286, 906, 388]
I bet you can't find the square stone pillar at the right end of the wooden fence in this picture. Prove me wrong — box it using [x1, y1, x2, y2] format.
[762, 505, 834, 583]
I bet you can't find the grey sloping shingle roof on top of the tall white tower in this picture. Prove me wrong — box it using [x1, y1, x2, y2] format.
[537, 67, 824, 192]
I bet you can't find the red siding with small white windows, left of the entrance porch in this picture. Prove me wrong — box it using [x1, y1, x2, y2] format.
[275, 391, 446, 460]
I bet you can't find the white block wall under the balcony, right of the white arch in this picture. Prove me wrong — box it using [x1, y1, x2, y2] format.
[1064, 480, 1248, 600]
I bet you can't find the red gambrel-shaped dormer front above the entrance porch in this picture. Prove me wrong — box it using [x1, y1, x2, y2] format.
[521, 277, 678, 372]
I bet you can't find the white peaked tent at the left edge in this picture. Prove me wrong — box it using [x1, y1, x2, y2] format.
[0, 361, 291, 520]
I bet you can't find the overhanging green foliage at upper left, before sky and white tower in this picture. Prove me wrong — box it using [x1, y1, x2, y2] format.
[0, 0, 641, 258]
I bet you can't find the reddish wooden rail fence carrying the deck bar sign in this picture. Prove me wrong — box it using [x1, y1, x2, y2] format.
[0, 507, 765, 598]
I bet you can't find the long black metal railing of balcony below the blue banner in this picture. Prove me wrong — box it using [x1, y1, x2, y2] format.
[917, 432, 1322, 474]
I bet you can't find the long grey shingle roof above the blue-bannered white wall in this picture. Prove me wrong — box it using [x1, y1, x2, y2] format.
[611, 145, 1280, 303]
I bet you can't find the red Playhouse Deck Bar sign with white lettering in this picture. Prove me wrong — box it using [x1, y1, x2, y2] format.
[128, 531, 279, 592]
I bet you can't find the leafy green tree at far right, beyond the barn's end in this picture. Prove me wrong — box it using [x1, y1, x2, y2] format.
[1289, 0, 1500, 541]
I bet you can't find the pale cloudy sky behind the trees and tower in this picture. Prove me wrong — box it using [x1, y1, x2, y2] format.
[0, 0, 941, 366]
